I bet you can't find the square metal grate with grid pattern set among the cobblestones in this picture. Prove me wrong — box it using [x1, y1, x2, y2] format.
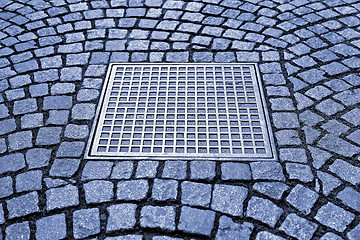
[87, 63, 274, 160]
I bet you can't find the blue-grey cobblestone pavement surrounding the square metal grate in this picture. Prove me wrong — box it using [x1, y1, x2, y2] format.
[0, 0, 360, 240]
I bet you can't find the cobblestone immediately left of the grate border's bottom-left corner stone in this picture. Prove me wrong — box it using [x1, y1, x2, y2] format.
[25, 148, 51, 169]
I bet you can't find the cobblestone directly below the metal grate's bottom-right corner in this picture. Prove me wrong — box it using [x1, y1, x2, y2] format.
[250, 162, 285, 181]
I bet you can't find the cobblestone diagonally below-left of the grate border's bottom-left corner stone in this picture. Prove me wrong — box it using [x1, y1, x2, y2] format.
[16, 170, 43, 192]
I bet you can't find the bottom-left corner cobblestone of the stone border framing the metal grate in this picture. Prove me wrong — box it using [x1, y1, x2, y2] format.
[49, 158, 80, 177]
